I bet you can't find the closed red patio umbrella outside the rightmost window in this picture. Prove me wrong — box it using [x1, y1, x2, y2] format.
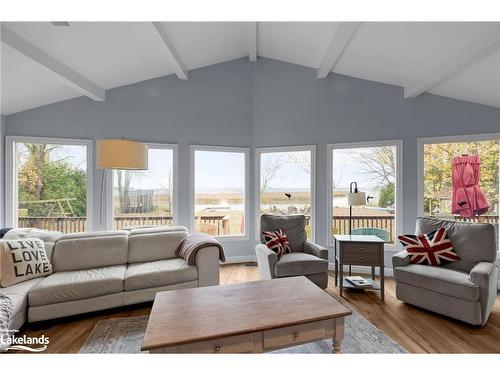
[451, 155, 490, 218]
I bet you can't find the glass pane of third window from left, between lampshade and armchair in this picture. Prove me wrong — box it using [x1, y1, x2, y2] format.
[194, 150, 245, 236]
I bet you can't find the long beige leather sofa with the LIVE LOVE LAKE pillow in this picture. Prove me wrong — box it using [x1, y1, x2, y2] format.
[0, 226, 219, 329]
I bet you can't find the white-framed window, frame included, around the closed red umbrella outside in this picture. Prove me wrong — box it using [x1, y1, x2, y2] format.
[419, 135, 500, 223]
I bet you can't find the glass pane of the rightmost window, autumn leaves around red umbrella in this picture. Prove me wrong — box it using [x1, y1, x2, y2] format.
[423, 140, 500, 223]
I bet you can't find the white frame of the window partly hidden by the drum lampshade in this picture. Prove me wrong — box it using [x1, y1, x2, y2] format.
[101, 142, 179, 230]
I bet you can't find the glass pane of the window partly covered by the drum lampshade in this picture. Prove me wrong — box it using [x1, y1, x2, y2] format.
[113, 147, 174, 229]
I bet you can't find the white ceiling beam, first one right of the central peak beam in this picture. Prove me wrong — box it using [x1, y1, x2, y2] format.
[316, 22, 361, 78]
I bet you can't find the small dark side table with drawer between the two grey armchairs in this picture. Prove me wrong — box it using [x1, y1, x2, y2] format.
[333, 235, 385, 301]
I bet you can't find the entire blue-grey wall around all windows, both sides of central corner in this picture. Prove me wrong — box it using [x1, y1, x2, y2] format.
[7, 58, 500, 264]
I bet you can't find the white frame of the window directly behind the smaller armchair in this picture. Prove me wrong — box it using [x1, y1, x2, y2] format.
[255, 145, 316, 242]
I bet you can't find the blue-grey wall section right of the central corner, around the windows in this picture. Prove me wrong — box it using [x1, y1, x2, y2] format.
[253, 59, 500, 265]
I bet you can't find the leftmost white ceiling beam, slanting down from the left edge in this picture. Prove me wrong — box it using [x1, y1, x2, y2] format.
[1, 25, 106, 101]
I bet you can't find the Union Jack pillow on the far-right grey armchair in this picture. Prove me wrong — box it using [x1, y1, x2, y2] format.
[398, 228, 460, 266]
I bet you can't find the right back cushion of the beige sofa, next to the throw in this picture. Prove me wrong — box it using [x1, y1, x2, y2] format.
[128, 226, 188, 263]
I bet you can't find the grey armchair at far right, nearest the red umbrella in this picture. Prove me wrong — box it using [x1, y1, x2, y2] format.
[392, 217, 498, 325]
